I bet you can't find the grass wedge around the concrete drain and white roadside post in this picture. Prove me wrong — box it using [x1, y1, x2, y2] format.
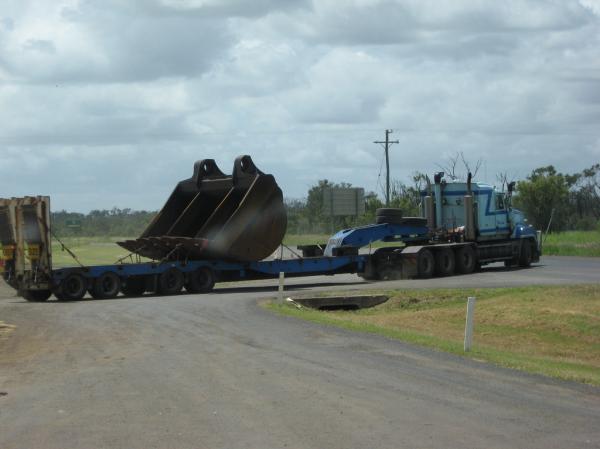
[266, 285, 600, 385]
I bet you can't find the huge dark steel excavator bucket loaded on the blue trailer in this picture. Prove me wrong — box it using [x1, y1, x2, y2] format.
[118, 156, 287, 262]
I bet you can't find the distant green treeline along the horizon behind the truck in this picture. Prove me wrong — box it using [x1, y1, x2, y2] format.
[52, 164, 600, 237]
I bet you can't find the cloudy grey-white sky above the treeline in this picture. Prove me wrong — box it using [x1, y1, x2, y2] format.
[0, 0, 600, 212]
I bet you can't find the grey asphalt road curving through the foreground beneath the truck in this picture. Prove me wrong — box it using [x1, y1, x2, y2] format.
[0, 257, 600, 449]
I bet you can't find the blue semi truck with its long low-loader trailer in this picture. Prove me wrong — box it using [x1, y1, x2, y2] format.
[0, 161, 542, 302]
